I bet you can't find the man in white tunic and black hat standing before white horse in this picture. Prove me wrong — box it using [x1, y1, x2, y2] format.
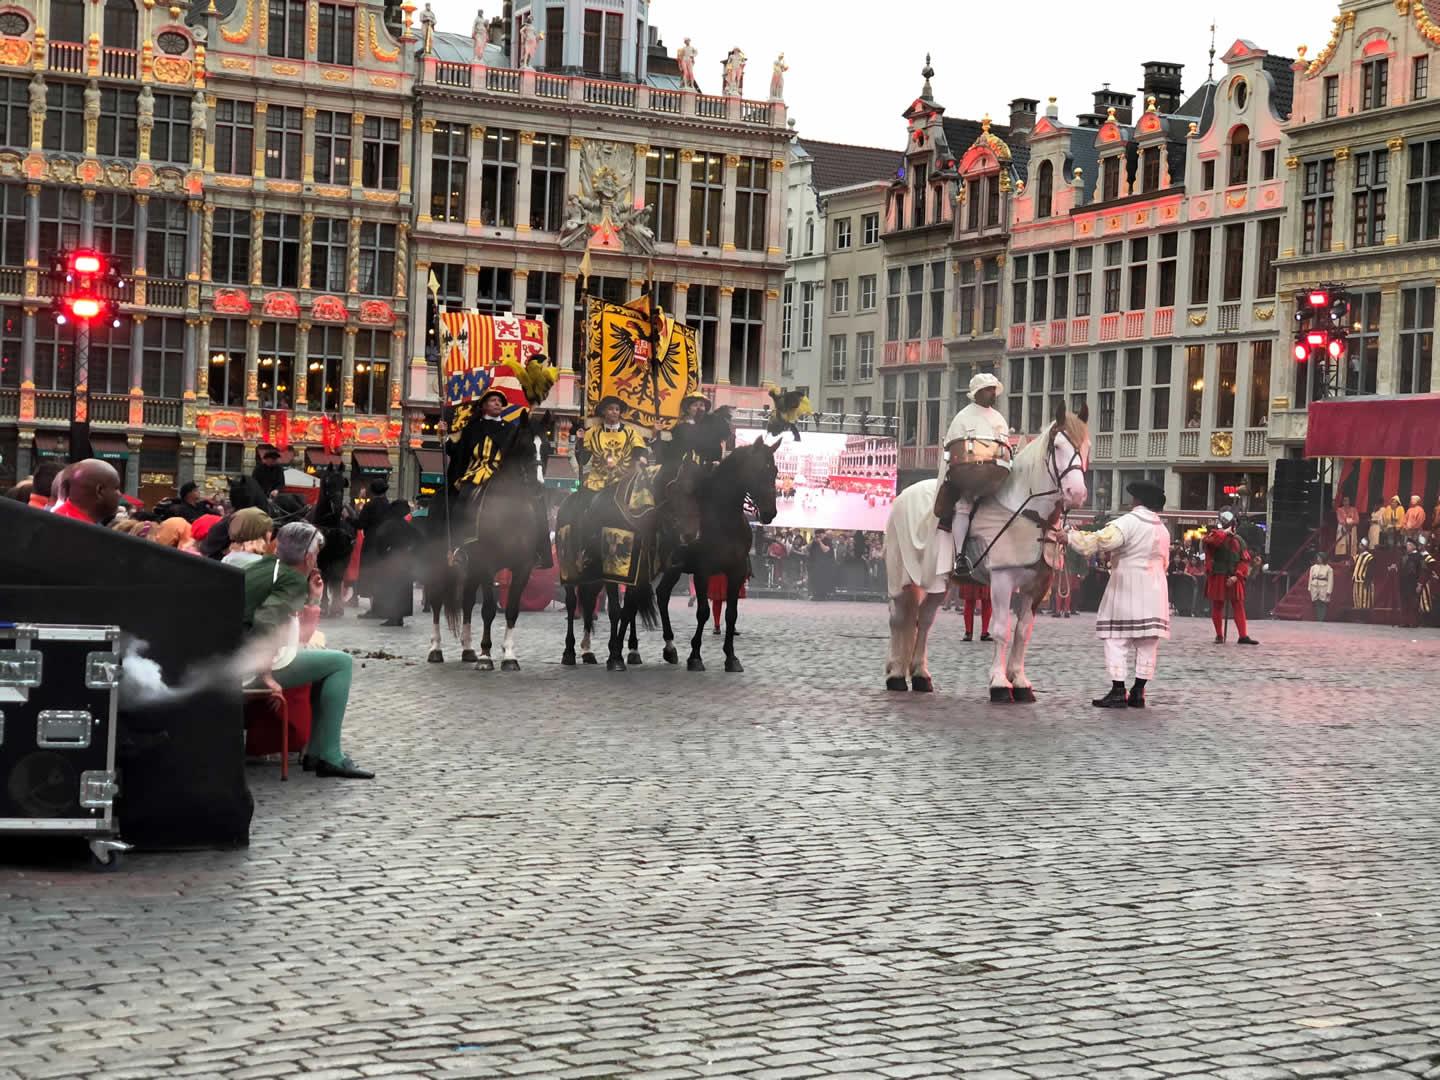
[1066, 481, 1171, 708]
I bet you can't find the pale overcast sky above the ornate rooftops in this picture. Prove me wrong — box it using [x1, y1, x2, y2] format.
[433, 0, 1339, 148]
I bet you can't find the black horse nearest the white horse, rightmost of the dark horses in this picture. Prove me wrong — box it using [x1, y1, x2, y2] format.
[655, 438, 778, 671]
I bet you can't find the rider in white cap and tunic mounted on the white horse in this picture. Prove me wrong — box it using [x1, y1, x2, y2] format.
[935, 372, 1012, 572]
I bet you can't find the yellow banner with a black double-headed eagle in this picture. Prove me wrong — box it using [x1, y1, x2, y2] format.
[585, 297, 700, 431]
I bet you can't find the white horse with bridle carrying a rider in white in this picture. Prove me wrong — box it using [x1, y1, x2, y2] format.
[886, 405, 1090, 704]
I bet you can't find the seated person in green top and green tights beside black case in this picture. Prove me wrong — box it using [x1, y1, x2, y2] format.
[245, 521, 374, 780]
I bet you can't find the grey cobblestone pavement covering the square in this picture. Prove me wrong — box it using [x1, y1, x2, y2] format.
[0, 600, 1440, 1080]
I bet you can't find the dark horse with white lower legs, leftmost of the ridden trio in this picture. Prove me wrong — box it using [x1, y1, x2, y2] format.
[425, 426, 549, 671]
